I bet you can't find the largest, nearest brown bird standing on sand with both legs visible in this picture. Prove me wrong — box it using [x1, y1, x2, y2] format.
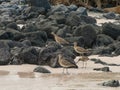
[58, 54, 78, 74]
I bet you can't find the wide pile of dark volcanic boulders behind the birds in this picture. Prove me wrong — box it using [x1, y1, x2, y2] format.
[0, 0, 120, 67]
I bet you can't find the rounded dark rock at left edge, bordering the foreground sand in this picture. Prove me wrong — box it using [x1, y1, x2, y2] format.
[0, 48, 11, 65]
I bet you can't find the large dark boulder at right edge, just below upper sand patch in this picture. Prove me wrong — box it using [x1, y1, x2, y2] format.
[102, 23, 120, 39]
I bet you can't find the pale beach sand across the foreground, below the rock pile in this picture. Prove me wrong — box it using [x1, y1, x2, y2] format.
[0, 56, 120, 90]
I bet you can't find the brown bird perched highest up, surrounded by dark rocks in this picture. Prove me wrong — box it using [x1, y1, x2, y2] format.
[51, 32, 69, 46]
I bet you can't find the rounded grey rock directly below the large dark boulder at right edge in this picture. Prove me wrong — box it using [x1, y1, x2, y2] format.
[95, 34, 114, 46]
